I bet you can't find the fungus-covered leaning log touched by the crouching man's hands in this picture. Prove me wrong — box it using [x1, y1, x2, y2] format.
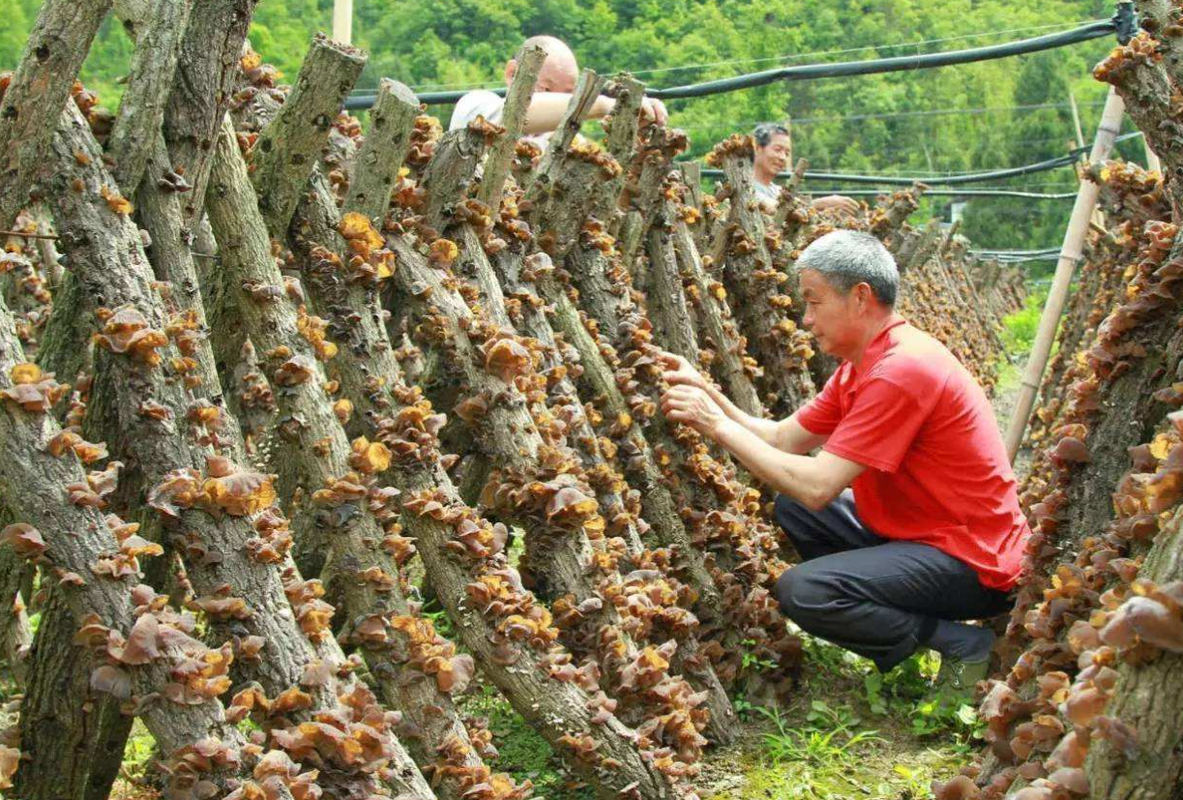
[558, 235, 799, 683]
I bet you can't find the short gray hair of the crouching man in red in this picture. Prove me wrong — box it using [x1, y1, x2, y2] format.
[797, 231, 899, 307]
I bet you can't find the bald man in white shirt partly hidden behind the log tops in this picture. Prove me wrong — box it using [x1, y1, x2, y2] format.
[448, 36, 667, 137]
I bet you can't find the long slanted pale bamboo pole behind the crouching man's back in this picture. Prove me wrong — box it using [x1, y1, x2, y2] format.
[1007, 89, 1125, 463]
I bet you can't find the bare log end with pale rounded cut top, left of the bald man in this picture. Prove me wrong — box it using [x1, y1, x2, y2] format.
[343, 78, 419, 226]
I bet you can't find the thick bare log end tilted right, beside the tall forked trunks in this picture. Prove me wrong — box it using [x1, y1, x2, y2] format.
[255, 33, 366, 239]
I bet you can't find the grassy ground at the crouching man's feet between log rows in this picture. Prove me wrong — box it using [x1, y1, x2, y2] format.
[700, 636, 981, 800]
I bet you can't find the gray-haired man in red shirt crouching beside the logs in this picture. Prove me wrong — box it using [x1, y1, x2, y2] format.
[661, 231, 1030, 692]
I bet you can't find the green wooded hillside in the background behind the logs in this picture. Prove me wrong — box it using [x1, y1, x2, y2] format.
[0, 0, 1144, 259]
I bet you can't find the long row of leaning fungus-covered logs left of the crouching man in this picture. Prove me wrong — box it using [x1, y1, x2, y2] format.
[0, 0, 1021, 800]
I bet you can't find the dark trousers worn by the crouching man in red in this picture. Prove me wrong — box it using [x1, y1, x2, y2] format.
[776, 489, 1010, 672]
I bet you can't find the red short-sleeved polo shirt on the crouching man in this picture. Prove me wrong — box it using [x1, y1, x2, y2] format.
[796, 317, 1030, 589]
